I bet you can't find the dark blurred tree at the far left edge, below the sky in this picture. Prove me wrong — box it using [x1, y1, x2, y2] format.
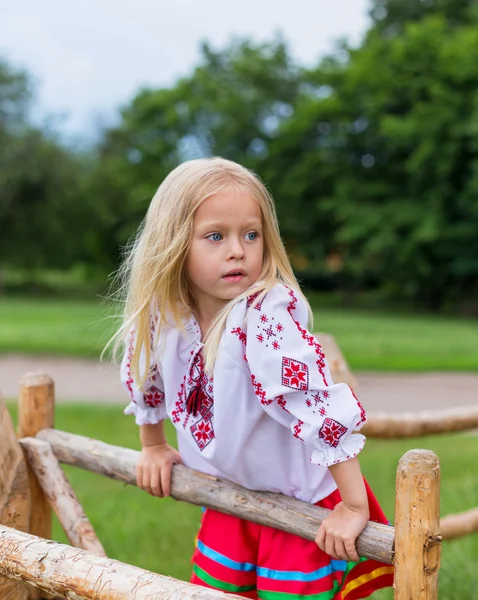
[0, 61, 93, 278]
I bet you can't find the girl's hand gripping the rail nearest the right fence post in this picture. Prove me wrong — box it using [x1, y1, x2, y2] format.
[315, 502, 370, 562]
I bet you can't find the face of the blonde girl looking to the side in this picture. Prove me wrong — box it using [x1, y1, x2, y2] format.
[186, 187, 264, 317]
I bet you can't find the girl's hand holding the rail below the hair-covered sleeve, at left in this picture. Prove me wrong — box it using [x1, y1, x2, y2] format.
[136, 443, 183, 498]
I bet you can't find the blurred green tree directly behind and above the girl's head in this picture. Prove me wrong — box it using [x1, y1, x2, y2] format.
[91, 40, 300, 266]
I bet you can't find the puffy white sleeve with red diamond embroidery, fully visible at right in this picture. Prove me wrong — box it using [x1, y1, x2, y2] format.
[242, 285, 366, 466]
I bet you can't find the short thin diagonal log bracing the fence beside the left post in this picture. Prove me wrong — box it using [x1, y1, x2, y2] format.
[20, 438, 106, 556]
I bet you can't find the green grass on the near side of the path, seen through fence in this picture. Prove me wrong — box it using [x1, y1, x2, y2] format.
[3, 405, 478, 600]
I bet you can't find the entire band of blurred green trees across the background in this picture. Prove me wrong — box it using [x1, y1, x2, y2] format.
[0, 8, 478, 314]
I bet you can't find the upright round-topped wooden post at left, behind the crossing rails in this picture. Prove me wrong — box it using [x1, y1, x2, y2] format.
[18, 373, 55, 600]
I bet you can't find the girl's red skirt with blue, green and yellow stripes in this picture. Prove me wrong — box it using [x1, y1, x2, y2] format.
[191, 483, 393, 600]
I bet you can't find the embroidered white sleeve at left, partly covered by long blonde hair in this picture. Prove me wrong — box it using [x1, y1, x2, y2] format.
[121, 318, 167, 425]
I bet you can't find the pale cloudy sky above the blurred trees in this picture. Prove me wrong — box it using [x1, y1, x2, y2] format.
[0, 0, 369, 138]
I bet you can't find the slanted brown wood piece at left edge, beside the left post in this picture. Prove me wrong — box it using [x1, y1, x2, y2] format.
[0, 397, 31, 600]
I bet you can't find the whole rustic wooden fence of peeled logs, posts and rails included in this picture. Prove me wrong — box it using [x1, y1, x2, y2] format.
[0, 374, 478, 600]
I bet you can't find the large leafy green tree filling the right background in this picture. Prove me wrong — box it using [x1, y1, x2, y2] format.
[275, 16, 478, 307]
